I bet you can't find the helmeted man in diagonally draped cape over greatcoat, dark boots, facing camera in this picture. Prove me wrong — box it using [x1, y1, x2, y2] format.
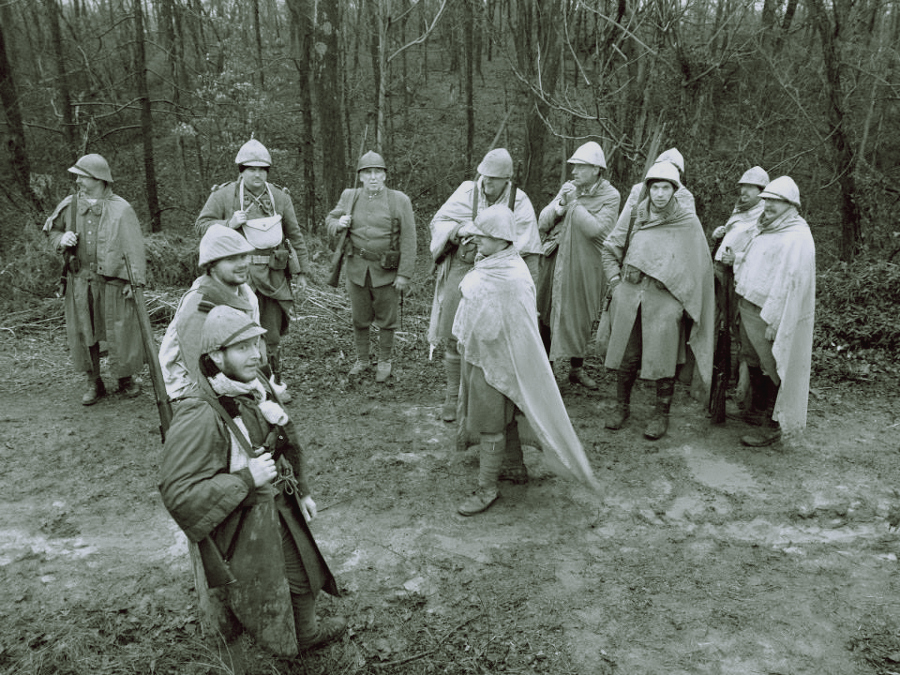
[603, 162, 715, 440]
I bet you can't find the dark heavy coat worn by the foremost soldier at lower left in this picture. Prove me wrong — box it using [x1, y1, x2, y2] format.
[159, 374, 339, 656]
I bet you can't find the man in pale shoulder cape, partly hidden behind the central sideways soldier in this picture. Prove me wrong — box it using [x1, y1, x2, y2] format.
[428, 148, 541, 422]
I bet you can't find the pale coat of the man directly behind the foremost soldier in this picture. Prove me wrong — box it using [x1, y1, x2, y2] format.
[159, 274, 266, 400]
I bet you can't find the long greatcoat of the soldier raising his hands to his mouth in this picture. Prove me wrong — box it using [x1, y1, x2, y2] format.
[537, 179, 619, 361]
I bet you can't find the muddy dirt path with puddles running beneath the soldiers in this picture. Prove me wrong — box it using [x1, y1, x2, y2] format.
[0, 330, 900, 675]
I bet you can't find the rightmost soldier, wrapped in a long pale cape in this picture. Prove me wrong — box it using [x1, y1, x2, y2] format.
[735, 176, 816, 447]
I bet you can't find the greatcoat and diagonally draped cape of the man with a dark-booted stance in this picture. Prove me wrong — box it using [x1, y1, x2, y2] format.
[603, 197, 715, 391]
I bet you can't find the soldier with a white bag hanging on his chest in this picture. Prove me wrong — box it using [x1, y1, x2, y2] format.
[195, 138, 309, 384]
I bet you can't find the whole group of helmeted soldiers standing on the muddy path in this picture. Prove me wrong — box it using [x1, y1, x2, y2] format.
[45, 139, 815, 655]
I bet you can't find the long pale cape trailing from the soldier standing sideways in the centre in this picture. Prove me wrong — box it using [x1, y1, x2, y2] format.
[453, 247, 597, 489]
